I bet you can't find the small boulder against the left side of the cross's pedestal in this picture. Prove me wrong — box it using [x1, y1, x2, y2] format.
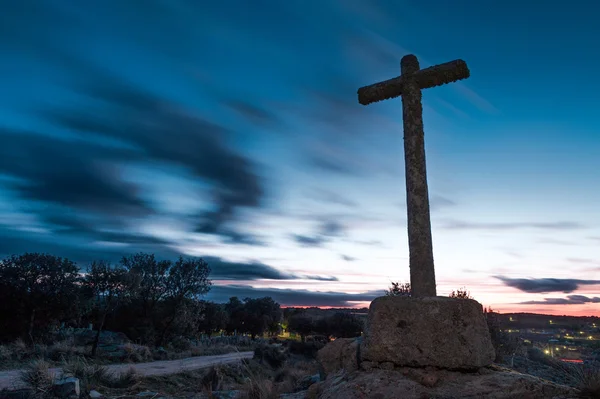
[317, 338, 360, 376]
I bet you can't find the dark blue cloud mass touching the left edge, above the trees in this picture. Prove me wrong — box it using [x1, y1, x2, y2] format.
[0, 129, 152, 216]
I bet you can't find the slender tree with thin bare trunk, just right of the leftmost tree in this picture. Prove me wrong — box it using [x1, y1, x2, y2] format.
[84, 261, 133, 357]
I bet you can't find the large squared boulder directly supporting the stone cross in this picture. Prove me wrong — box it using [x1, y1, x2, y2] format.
[360, 296, 495, 369]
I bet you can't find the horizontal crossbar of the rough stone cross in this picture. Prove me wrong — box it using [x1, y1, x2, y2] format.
[358, 60, 470, 105]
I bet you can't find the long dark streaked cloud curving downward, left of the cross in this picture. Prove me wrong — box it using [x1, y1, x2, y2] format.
[43, 71, 264, 243]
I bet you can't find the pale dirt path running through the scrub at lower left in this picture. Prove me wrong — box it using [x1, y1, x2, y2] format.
[0, 352, 254, 390]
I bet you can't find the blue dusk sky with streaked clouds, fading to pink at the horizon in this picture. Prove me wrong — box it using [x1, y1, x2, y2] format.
[0, 0, 600, 316]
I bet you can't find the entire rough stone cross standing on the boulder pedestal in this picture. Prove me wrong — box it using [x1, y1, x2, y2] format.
[358, 54, 470, 297]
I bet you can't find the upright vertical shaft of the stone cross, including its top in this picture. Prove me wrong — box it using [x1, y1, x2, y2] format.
[400, 55, 436, 297]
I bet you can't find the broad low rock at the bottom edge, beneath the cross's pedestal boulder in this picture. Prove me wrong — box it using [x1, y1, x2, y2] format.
[306, 368, 578, 399]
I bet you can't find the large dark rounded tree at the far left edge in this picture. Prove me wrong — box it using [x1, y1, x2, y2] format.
[0, 253, 79, 344]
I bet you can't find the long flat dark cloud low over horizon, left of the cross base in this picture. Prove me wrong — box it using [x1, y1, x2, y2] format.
[206, 285, 384, 307]
